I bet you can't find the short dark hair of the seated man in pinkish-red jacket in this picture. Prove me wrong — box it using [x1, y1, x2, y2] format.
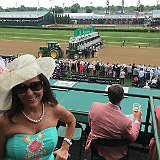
[108, 84, 124, 104]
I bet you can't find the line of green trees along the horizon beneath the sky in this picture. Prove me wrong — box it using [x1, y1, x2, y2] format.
[0, 3, 160, 14]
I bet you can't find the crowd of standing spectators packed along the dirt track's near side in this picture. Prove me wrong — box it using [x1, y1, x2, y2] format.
[55, 59, 160, 88]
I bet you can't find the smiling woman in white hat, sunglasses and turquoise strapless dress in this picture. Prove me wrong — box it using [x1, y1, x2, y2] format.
[0, 55, 76, 160]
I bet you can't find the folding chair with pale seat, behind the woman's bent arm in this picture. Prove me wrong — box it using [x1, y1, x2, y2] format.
[57, 122, 86, 160]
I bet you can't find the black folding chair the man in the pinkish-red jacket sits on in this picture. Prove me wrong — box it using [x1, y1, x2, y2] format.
[91, 138, 130, 160]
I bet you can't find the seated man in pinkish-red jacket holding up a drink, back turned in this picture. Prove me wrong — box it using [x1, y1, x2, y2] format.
[85, 84, 142, 160]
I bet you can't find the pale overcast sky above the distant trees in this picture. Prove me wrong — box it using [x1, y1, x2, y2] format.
[0, 0, 160, 8]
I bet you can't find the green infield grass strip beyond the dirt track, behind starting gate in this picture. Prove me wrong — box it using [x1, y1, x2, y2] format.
[0, 28, 160, 48]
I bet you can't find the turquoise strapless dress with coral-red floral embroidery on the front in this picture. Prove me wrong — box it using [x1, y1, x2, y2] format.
[4, 127, 58, 160]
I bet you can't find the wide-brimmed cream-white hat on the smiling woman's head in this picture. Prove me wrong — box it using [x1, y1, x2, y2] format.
[0, 54, 55, 110]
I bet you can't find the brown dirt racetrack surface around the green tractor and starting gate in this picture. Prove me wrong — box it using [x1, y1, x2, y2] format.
[0, 40, 160, 67]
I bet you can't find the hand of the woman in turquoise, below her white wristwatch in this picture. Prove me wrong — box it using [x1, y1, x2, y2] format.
[53, 146, 68, 160]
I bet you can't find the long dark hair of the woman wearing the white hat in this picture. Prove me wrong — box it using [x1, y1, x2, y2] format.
[5, 73, 58, 123]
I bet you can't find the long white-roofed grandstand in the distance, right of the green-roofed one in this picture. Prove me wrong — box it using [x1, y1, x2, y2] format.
[64, 13, 152, 25]
